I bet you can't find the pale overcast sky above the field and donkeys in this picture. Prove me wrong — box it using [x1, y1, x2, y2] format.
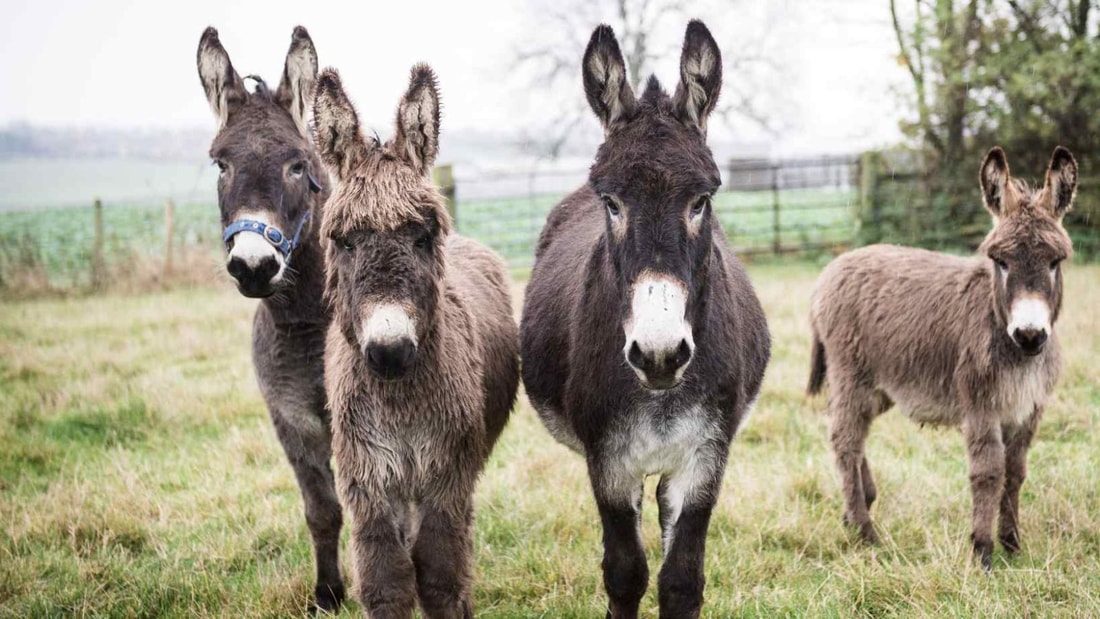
[0, 0, 905, 153]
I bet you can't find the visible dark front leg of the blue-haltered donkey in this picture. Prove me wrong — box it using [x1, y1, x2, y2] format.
[272, 410, 345, 612]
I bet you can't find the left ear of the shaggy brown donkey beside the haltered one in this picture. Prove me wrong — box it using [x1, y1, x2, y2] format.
[314, 68, 365, 180]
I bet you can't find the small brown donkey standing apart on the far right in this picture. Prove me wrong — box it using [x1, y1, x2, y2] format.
[809, 146, 1077, 571]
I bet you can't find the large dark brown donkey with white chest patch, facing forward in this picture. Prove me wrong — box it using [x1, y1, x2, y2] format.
[520, 21, 770, 618]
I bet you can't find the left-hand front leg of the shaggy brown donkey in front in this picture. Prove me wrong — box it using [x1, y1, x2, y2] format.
[341, 480, 416, 619]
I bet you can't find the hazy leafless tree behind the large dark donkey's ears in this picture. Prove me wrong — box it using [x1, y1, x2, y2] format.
[512, 0, 781, 158]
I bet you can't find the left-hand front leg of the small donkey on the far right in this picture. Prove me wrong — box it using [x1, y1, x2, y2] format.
[963, 412, 1004, 572]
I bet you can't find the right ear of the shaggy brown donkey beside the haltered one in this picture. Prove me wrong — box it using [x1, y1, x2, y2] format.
[394, 64, 439, 176]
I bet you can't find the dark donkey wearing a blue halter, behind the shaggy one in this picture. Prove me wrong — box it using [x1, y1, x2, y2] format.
[198, 26, 344, 611]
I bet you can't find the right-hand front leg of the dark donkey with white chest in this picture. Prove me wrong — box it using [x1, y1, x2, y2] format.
[657, 457, 725, 618]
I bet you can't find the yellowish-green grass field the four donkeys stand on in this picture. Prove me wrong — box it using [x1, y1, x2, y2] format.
[0, 263, 1100, 617]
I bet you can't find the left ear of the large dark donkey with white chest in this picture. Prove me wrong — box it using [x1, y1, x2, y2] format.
[581, 24, 636, 134]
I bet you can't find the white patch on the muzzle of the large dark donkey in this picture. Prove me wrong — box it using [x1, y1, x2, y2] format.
[623, 274, 695, 365]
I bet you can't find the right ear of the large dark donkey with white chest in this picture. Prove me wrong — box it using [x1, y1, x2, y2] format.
[673, 20, 722, 133]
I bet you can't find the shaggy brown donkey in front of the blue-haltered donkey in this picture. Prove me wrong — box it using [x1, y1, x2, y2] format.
[314, 65, 519, 619]
